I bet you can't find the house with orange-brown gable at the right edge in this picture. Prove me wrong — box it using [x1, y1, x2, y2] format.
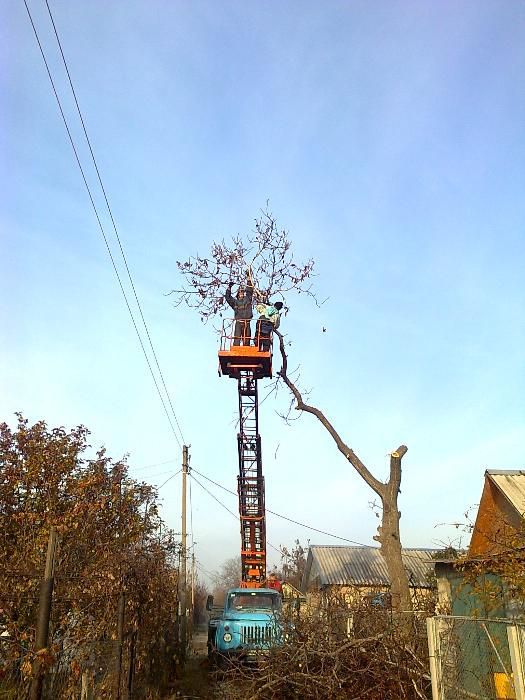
[429, 470, 525, 698]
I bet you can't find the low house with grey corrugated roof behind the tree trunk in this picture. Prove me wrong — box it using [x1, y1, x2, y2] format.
[301, 545, 436, 607]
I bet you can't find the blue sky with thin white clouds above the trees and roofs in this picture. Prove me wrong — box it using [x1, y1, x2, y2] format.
[0, 0, 525, 579]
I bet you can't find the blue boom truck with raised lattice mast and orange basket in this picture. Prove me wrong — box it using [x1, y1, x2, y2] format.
[206, 320, 283, 664]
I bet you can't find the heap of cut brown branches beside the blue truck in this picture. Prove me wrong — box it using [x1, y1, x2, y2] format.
[213, 606, 430, 700]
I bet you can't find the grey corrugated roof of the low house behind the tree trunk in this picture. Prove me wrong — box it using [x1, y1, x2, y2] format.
[307, 545, 436, 588]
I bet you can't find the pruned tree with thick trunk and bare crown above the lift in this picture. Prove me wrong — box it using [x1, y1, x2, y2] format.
[173, 210, 412, 612]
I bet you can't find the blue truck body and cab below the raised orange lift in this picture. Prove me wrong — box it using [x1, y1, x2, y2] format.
[206, 588, 284, 666]
